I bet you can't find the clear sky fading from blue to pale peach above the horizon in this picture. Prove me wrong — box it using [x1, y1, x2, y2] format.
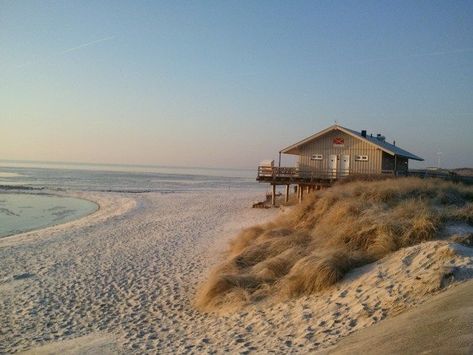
[0, 0, 473, 168]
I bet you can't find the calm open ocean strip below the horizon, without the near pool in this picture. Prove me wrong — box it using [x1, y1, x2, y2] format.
[0, 162, 259, 192]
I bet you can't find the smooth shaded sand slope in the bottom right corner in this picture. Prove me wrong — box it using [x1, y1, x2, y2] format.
[320, 281, 473, 354]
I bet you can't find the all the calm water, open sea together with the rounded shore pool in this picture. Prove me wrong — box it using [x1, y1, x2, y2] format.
[0, 160, 264, 238]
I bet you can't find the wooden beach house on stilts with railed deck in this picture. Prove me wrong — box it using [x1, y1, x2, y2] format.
[256, 124, 423, 206]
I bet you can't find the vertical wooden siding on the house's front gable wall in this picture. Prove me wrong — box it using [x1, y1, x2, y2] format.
[298, 130, 383, 174]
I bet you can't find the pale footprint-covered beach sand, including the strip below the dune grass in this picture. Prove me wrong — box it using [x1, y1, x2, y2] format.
[0, 190, 473, 353]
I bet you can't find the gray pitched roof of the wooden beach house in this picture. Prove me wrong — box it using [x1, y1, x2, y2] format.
[281, 125, 424, 161]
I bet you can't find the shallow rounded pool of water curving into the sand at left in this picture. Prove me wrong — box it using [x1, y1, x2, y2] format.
[0, 193, 98, 238]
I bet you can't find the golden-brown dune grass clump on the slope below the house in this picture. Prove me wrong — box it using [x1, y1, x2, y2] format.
[195, 178, 473, 311]
